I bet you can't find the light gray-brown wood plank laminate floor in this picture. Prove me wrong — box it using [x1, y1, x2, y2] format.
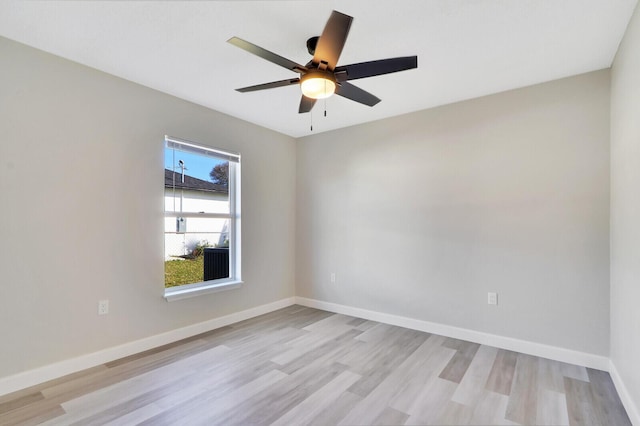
[0, 306, 631, 426]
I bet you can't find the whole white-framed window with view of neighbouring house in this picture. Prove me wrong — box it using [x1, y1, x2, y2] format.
[164, 136, 241, 300]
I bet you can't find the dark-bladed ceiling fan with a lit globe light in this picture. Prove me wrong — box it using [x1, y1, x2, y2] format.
[227, 10, 418, 113]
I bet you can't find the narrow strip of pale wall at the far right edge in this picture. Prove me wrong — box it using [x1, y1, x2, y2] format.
[611, 0, 640, 412]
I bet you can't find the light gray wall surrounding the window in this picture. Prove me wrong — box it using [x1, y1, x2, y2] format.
[0, 38, 296, 377]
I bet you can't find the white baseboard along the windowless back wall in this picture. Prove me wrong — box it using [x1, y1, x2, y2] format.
[295, 297, 610, 371]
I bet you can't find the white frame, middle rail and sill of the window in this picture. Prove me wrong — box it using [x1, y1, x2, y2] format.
[163, 136, 242, 302]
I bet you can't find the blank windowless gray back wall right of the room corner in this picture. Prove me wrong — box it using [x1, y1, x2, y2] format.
[296, 71, 609, 356]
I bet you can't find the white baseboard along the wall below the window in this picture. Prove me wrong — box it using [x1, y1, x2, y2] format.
[0, 297, 295, 396]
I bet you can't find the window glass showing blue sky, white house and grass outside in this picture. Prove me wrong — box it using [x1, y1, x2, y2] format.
[164, 142, 238, 288]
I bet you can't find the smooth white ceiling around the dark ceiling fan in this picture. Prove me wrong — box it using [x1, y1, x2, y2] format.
[0, 0, 637, 137]
